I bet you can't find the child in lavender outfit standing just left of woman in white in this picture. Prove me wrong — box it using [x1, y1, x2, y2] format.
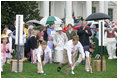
[46, 36, 54, 63]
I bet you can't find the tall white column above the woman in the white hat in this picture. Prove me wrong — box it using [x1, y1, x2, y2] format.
[65, 1, 74, 25]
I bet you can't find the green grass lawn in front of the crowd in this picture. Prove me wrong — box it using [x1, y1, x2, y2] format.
[1, 57, 117, 78]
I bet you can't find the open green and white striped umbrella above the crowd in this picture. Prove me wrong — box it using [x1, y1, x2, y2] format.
[40, 16, 63, 26]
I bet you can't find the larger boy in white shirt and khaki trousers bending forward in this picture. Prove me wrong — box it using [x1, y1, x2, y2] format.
[57, 36, 85, 74]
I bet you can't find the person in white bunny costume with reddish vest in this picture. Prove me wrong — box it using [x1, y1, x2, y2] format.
[105, 24, 117, 59]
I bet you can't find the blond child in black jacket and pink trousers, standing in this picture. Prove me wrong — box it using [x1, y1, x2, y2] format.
[30, 30, 37, 64]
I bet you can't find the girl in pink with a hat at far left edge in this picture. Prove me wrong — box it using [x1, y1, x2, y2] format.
[1, 34, 13, 72]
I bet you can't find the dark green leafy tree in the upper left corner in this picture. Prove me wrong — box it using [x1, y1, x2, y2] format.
[1, 1, 42, 29]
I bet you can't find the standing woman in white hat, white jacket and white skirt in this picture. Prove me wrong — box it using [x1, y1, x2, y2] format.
[53, 27, 68, 62]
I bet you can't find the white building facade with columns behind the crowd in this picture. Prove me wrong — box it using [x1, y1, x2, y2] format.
[38, 1, 117, 24]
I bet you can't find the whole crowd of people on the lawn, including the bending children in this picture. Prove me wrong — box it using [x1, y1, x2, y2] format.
[1, 21, 116, 74]
